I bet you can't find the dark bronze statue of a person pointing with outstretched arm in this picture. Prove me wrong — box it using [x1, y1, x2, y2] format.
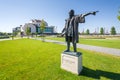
[62, 10, 98, 52]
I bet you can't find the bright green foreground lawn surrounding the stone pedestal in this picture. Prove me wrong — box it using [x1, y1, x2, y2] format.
[0, 39, 120, 80]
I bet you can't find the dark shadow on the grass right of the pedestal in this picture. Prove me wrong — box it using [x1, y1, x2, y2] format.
[80, 67, 120, 80]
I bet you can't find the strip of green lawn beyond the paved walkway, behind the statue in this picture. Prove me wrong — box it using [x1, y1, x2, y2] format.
[47, 37, 120, 49]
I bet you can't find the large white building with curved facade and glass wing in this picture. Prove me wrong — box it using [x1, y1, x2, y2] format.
[12, 19, 56, 35]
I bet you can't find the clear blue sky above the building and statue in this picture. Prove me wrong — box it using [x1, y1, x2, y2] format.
[0, 0, 120, 33]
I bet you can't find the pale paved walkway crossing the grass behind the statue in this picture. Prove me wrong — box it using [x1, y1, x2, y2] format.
[34, 39, 120, 56]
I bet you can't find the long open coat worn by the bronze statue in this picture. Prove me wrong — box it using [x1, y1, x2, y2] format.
[62, 15, 85, 43]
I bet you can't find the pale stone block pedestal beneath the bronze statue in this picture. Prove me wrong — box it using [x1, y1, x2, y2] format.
[61, 52, 82, 75]
